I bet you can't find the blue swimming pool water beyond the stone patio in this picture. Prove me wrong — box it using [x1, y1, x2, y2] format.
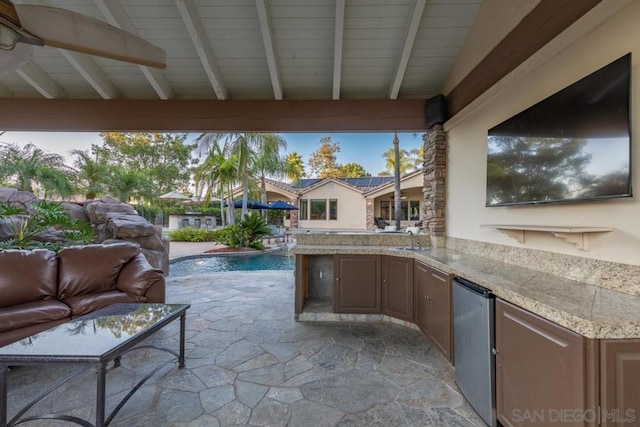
[169, 253, 294, 277]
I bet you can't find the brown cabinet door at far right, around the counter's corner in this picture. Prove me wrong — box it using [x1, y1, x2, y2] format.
[600, 339, 640, 427]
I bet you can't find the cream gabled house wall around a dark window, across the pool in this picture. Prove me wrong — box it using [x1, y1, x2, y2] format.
[298, 182, 367, 230]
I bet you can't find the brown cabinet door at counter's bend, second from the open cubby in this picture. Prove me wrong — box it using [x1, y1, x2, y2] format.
[382, 256, 413, 322]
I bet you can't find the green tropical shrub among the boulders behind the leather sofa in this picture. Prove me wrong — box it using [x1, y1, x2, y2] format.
[0, 200, 94, 251]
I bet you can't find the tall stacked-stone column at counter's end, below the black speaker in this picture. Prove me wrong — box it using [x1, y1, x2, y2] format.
[422, 125, 447, 246]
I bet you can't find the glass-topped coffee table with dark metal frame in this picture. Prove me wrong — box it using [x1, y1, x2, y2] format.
[0, 304, 190, 427]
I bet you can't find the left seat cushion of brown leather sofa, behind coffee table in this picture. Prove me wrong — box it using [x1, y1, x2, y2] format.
[0, 299, 71, 332]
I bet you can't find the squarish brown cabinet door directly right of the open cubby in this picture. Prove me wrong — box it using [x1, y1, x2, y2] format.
[333, 255, 381, 313]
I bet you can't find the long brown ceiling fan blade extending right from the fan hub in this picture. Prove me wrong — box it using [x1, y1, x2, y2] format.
[15, 5, 167, 69]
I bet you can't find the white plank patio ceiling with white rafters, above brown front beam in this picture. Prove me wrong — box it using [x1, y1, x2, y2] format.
[0, 0, 481, 100]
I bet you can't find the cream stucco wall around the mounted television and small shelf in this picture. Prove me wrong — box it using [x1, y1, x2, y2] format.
[445, 1, 640, 265]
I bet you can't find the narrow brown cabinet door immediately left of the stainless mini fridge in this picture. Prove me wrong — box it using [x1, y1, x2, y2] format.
[427, 268, 453, 361]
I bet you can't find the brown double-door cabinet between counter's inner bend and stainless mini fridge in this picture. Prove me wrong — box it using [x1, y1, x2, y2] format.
[413, 262, 453, 361]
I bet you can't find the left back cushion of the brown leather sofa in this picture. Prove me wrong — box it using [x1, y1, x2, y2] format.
[0, 249, 58, 310]
